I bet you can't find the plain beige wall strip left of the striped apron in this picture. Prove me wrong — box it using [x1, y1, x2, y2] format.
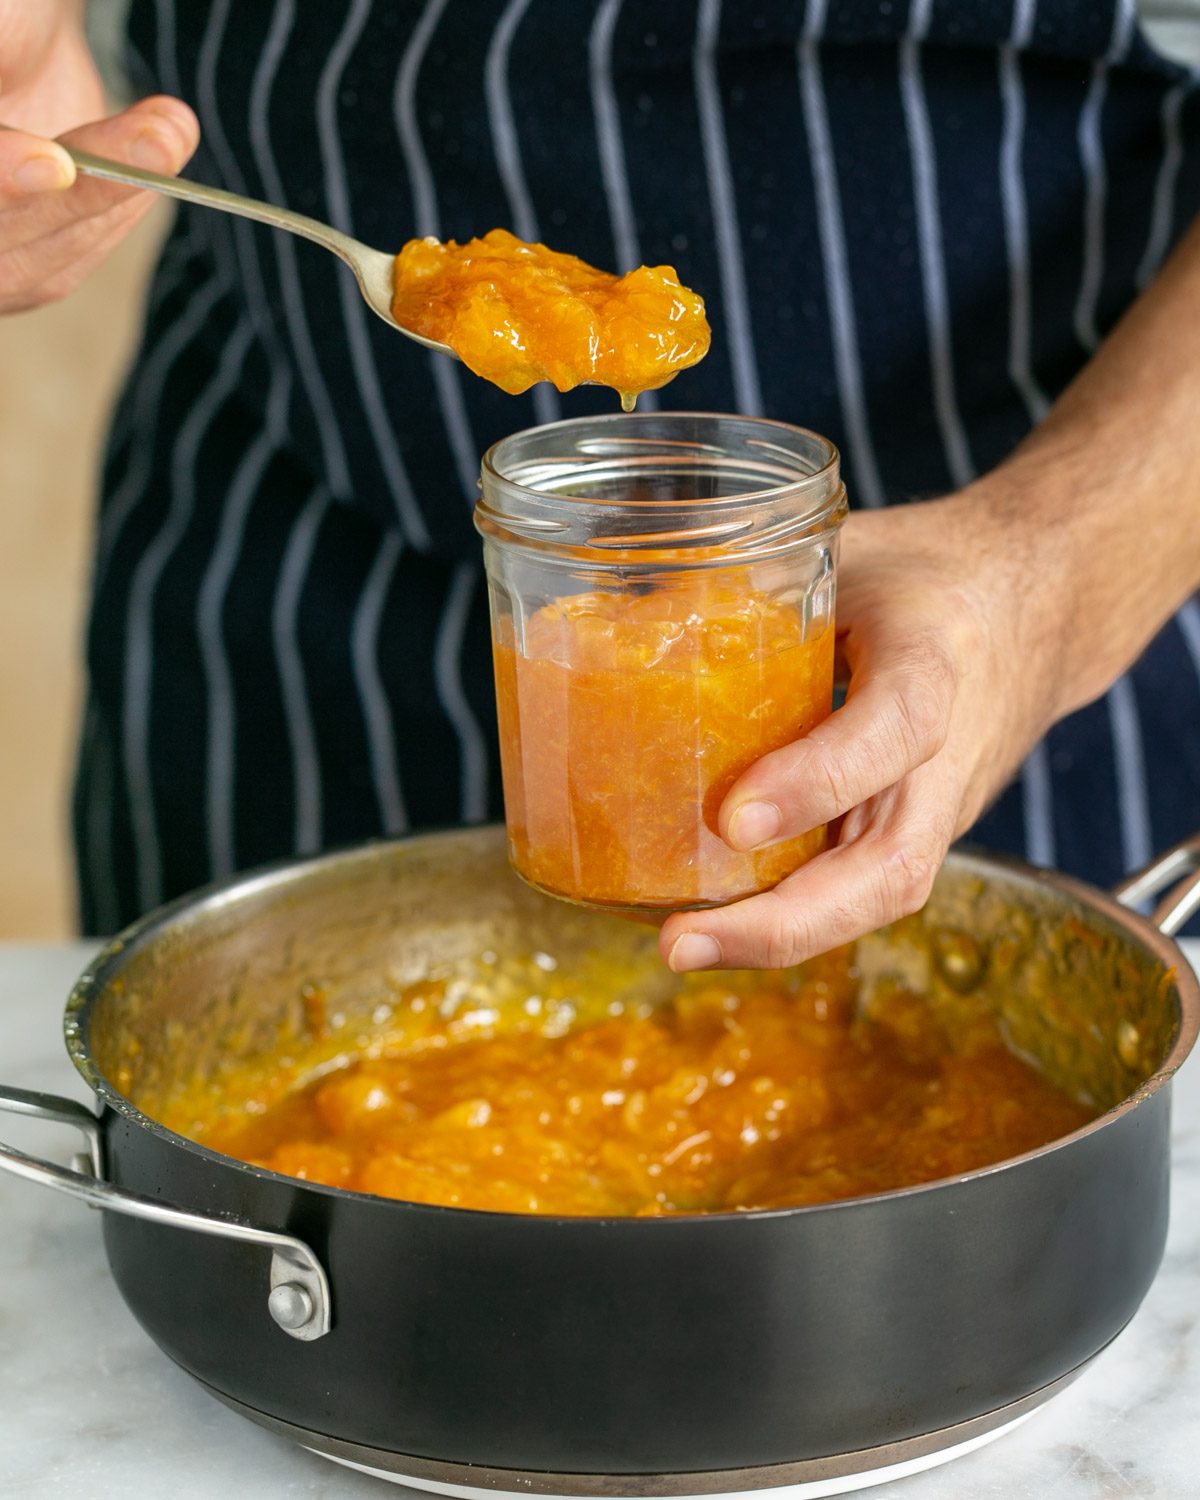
[0, 210, 165, 939]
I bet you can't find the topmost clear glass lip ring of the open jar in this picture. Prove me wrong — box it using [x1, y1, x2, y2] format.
[480, 411, 840, 521]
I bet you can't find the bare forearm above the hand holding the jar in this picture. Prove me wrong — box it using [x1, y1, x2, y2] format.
[972, 211, 1200, 717]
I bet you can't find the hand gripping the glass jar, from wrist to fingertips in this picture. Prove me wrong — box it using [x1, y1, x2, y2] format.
[660, 491, 1065, 971]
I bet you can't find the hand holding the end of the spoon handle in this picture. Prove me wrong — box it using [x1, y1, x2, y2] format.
[0, 0, 200, 312]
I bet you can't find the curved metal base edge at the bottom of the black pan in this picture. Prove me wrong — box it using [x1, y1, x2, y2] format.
[206, 1355, 1097, 1500]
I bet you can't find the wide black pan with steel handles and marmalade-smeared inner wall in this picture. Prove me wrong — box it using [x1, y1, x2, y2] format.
[0, 828, 1200, 1496]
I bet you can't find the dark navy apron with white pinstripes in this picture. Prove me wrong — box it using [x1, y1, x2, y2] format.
[75, 0, 1200, 933]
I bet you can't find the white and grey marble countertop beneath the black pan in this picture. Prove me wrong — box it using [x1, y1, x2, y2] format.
[0, 944, 1200, 1500]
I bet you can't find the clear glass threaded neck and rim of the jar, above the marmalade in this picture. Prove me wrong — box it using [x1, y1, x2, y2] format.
[476, 411, 848, 566]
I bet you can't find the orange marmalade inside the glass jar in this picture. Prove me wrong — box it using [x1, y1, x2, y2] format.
[494, 575, 834, 911]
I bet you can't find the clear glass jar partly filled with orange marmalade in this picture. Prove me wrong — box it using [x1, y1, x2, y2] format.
[476, 413, 846, 917]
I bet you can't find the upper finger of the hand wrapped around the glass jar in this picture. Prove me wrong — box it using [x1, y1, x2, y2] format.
[717, 636, 959, 851]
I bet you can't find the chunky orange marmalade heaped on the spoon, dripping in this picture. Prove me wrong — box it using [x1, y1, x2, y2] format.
[392, 230, 710, 411]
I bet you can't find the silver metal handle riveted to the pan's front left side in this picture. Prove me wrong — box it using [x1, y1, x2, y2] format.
[0, 1085, 333, 1341]
